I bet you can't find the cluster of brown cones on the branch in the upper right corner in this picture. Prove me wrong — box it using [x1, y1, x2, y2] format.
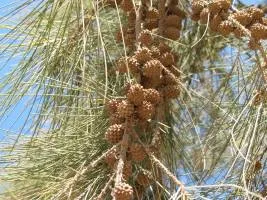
[191, 0, 267, 49]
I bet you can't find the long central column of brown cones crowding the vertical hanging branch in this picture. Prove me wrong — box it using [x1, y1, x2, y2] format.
[99, 0, 185, 200]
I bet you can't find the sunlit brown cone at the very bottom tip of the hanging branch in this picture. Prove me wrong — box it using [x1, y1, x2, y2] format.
[112, 182, 133, 200]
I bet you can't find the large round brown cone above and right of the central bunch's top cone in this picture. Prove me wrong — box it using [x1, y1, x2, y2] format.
[143, 59, 163, 79]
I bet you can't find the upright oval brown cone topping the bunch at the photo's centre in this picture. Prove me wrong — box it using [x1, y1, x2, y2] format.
[127, 84, 144, 106]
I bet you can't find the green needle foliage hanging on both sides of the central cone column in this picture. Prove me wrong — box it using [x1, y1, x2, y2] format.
[0, 0, 267, 200]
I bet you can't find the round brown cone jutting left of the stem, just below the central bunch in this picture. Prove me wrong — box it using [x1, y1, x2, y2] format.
[105, 124, 124, 144]
